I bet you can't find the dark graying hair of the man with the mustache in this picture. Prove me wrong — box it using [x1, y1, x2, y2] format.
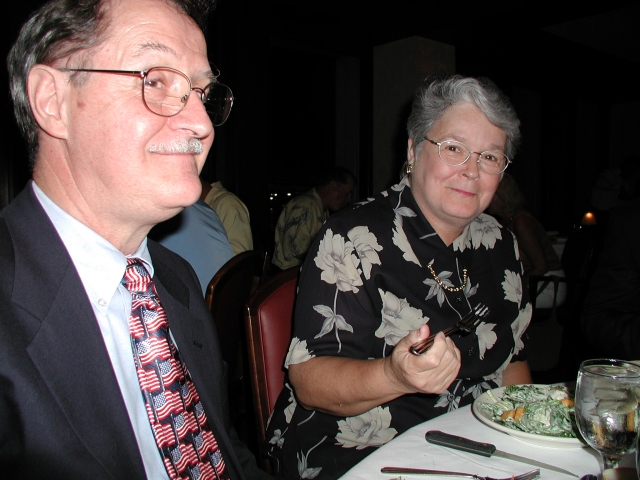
[7, 0, 215, 167]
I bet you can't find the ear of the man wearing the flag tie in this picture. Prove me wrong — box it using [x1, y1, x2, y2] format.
[27, 64, 68, 138]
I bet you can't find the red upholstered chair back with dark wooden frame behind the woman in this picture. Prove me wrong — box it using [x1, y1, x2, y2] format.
[245, 267, 299, 445]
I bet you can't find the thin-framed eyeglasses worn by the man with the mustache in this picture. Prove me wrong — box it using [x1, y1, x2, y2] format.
[58, 67, 233, 126]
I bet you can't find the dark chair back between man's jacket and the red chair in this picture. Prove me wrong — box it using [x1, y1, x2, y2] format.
[205, 250, 262, 384]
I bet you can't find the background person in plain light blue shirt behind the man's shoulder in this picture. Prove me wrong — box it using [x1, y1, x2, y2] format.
[149, 196, 234, 295]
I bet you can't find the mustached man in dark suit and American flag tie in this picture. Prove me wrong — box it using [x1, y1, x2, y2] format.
[0, 0, 268, 480]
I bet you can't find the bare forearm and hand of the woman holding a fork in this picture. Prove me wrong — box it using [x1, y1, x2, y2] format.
[289, 325, 460, 416]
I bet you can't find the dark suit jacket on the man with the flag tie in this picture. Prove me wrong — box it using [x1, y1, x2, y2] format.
[0, 185, 270, 480]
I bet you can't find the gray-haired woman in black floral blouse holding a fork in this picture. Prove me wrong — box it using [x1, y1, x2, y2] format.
[266, 76, 531, 479]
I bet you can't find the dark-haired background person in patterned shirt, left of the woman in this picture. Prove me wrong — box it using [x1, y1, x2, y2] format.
[271, 166, 356, 270]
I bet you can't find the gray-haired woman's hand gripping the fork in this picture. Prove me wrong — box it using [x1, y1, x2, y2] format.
[385, 324, 460, 394]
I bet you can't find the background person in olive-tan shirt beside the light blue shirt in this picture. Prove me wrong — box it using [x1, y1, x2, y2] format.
[202, 181, 253, 255]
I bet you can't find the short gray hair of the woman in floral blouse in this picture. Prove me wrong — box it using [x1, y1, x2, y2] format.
[407, 75, 520, 159]
